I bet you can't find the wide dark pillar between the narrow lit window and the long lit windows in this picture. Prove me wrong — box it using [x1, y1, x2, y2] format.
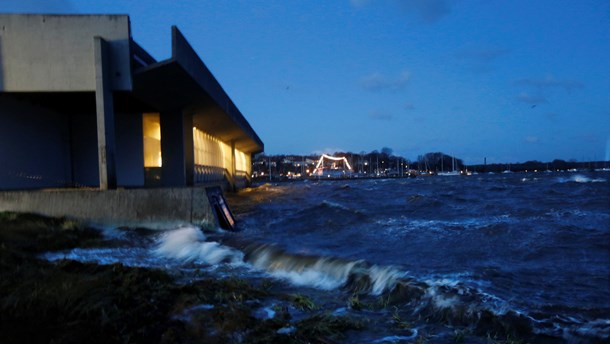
[161, 110, 195, 187]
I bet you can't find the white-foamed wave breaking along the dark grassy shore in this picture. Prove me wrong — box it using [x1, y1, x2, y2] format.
[154, 227, 610, 340]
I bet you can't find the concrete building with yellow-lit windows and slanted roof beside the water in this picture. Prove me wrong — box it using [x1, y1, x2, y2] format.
[0, 14, 264, 228]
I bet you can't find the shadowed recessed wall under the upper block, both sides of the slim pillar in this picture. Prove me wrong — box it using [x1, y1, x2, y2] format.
[0, 95, 144, 190]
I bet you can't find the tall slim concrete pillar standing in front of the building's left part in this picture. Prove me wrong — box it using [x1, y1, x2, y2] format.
[93, 36, 116, 190]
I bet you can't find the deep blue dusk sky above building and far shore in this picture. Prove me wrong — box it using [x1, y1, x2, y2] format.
[0, 0, 610, 163]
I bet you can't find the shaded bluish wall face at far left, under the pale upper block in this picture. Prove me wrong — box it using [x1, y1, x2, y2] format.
[0, 95, 72, 190]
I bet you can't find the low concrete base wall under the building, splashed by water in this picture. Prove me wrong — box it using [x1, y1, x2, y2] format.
[0, 187, 216, 228]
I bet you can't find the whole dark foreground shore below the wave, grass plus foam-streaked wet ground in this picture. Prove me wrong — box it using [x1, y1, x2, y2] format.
[0, 212, 553, 343]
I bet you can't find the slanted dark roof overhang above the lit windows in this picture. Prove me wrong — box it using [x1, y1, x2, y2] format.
[133, 26, 264, 153]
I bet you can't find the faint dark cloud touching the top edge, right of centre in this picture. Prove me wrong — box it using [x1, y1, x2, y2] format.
[350, 0, 452, 23]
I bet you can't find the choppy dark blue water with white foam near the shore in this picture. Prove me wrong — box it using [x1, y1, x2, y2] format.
[48, 172, 610, 342]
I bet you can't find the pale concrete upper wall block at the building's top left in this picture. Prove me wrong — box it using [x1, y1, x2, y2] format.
[0, 14, 132, 92]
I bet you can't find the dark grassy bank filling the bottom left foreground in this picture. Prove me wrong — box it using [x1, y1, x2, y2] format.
[0, 212, 365, 343]
